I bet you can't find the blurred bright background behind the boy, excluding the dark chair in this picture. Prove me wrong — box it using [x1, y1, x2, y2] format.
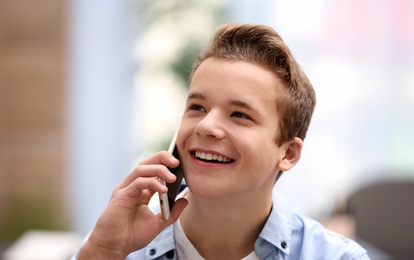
[0, 0, 414, 259]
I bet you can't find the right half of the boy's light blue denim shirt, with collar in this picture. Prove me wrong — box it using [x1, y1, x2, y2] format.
[257, 192, 369, 260]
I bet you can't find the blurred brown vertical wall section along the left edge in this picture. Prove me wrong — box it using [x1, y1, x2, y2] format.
[0, 0, 67, 241]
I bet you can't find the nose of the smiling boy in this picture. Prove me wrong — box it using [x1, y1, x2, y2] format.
[195, 110, 225, 139]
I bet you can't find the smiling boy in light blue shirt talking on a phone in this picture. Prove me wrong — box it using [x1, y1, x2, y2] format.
[74, 24, 369, 260]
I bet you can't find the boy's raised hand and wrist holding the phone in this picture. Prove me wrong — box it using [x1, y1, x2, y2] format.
[78, 151, 187, 259]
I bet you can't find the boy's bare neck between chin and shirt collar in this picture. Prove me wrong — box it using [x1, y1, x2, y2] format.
[180, 189, 272, 259]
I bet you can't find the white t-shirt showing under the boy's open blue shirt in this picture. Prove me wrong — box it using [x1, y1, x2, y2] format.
[174, 220, 260, 260]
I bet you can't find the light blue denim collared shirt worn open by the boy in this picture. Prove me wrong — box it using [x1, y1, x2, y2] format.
[73, 190, 369, 260]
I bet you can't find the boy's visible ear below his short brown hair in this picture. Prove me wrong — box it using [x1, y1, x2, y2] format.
[277, 137, 303, 172]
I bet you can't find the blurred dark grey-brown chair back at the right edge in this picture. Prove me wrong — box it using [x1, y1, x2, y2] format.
[347, 180, 414, 259]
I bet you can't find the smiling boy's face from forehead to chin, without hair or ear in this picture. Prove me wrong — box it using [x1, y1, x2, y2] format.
[177, 58, 284, 198]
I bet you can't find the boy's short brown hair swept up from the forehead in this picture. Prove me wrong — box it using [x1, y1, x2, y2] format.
[190, 23, 316, 145]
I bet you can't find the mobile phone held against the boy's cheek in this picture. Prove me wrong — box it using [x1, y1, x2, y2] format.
[159, 130, 184, 220]
